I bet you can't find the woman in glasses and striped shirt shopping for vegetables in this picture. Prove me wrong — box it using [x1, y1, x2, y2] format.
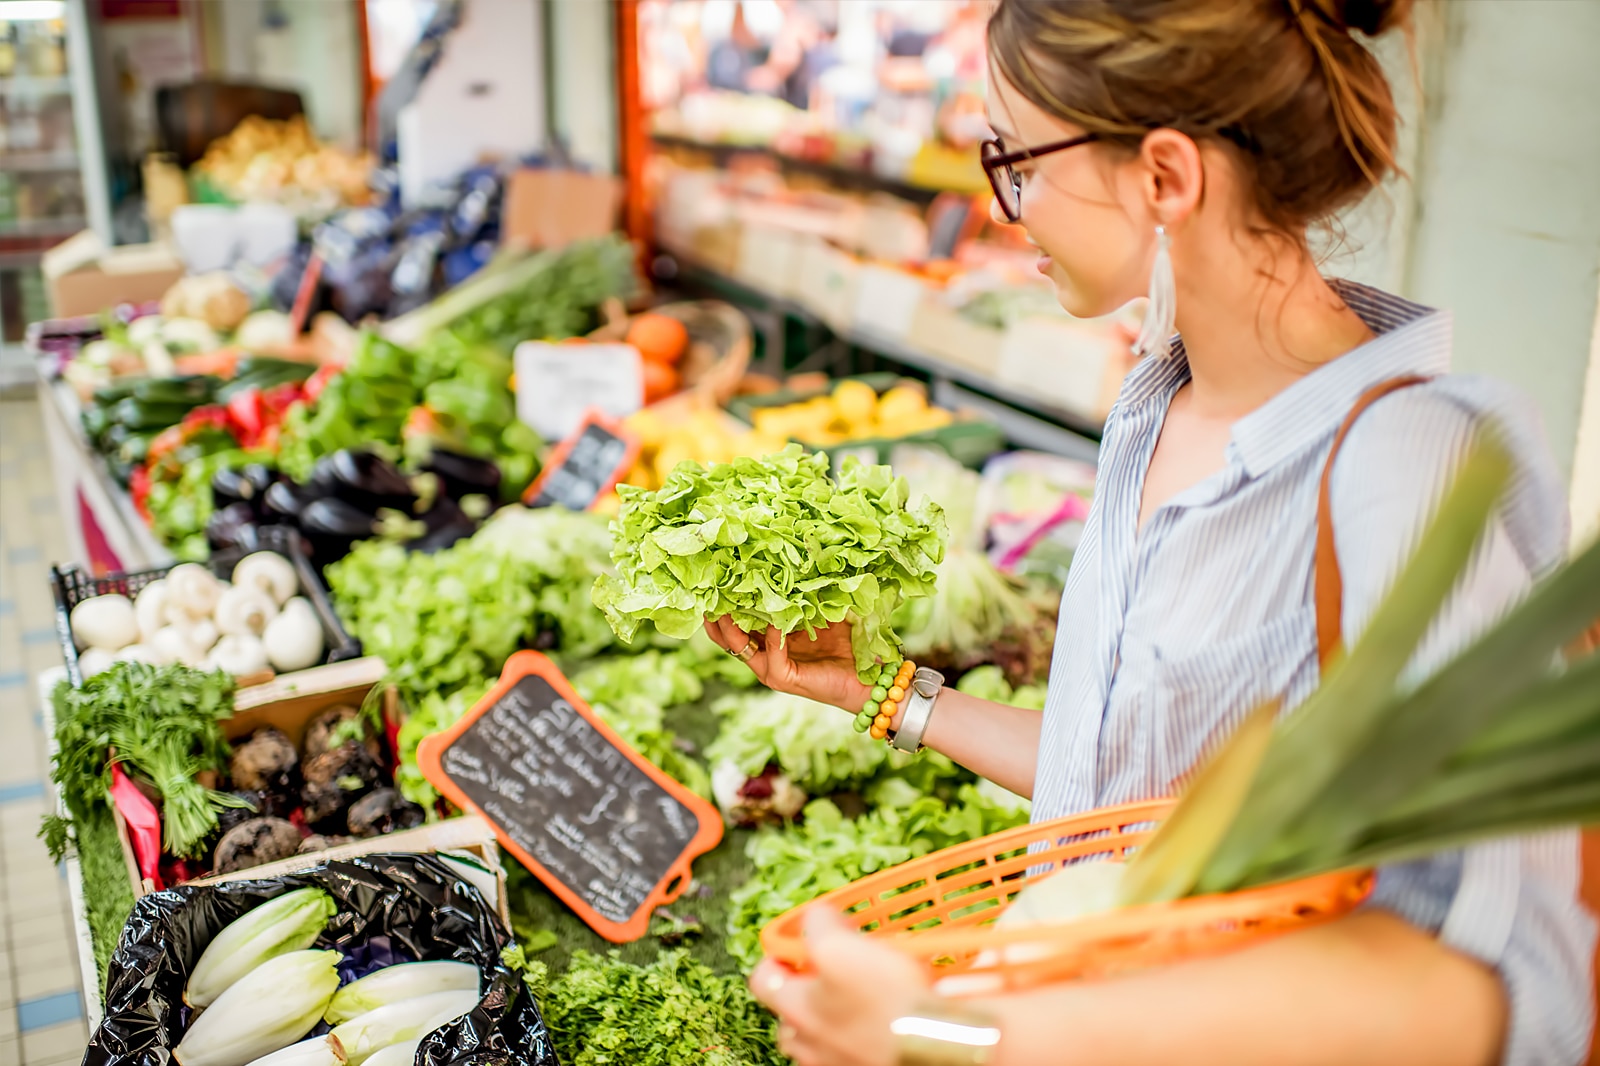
[707, 0, 1595, 1066]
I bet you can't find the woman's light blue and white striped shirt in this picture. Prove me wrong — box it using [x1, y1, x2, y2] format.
[1034, 283, 1595, 1066]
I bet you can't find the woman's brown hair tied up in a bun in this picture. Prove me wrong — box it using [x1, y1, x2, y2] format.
[989, 0, 1411, 235]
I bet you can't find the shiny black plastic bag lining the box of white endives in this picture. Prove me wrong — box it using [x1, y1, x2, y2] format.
[83, 853, 558, 1066]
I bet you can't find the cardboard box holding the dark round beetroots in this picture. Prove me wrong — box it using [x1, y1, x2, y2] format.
[112, 646, 509, 920]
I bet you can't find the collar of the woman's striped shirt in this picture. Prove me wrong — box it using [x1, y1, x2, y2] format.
[1123, 280, 1451, 477]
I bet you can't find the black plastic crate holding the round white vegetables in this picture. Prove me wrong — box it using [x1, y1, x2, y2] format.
[50, 525, 362, 688]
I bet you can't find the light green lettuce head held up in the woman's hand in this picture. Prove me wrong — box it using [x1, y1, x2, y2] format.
[594, 445, 946, 671]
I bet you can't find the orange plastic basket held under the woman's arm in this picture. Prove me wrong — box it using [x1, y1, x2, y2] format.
[762, 800, 1373, 996]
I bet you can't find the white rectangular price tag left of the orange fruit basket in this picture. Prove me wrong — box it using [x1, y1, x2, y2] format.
[515, 341, 645, 440]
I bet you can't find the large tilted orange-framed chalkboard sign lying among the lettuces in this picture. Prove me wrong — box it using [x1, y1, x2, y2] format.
[418, 651, 722, 943]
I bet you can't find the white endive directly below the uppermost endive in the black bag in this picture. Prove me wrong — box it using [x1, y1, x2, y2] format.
[173, 951, 339, 1066]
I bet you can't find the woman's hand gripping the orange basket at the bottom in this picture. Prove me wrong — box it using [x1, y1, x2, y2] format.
[750, 908, 928, 1066]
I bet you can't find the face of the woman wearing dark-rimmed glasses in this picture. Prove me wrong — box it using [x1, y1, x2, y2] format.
[989, 64, 1155, 319]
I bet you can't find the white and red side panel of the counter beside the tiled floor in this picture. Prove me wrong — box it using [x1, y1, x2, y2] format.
[37, 375, 173, 575]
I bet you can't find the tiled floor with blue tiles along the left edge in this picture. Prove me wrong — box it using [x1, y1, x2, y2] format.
[0, 399, 88, 1066]
